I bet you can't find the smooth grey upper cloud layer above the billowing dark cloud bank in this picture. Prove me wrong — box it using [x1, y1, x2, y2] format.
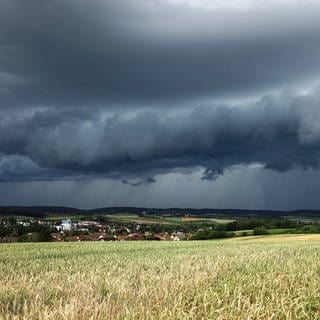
[0, 0, 320, 109]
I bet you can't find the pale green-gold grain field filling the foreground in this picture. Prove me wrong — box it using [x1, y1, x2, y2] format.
[0, 235, 320, 320]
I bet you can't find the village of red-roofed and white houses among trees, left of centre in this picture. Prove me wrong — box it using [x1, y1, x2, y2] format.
[0, 218, 192, 243]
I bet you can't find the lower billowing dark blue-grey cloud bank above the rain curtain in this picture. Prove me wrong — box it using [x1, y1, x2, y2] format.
[0, 90, 320, 180]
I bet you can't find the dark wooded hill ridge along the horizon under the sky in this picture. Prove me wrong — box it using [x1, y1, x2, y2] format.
[0, 206, 320, 219]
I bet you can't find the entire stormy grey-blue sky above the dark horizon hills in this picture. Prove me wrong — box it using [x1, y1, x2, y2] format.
[0, 0, 320, 210]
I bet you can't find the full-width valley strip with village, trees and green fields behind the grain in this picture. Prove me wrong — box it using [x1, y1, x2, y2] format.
[0, 213, 320, 243]
